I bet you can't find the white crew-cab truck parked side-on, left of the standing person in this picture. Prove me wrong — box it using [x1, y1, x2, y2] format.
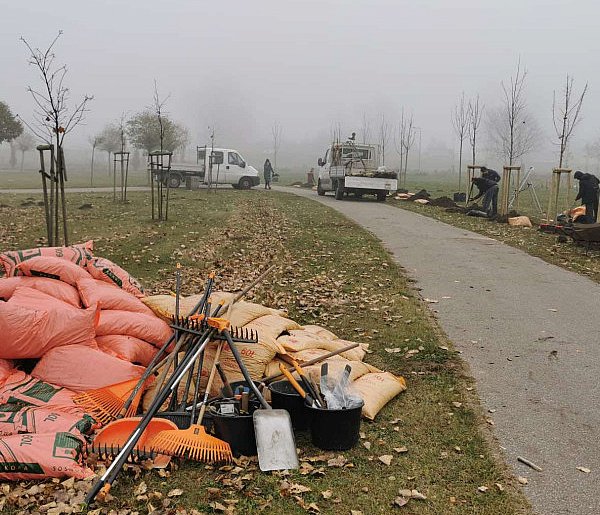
[169, 147, 260, 190]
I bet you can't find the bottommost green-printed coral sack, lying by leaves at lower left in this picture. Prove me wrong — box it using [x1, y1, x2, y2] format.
[0, 433, 93, 481]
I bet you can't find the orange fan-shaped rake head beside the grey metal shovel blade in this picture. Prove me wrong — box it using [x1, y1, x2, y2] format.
[147, 424, 233, 463]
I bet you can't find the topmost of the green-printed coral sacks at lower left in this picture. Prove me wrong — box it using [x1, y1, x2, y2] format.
[0, 370, 81, 413]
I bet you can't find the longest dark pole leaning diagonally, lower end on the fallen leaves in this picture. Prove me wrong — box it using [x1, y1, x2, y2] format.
[85, 265, 276, 506]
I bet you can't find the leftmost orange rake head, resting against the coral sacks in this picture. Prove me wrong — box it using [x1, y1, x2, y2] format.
[73, 376, 154, 425]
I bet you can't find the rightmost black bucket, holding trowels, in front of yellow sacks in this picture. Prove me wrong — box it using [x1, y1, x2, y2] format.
[306, 401, 364, 451]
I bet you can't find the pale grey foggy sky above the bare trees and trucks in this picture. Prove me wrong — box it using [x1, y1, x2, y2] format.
[0, 0, 600, 171]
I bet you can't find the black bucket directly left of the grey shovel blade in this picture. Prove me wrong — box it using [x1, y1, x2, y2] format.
[208, 399, 260, 456]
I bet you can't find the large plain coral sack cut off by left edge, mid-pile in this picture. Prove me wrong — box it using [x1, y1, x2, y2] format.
[0, 286, 98, 359]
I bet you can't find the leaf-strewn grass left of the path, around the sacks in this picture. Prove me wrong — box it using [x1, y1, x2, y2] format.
[0, 190, 529, 515]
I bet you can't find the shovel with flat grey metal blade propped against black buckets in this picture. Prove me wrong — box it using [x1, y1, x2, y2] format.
[223, 329, 300, 472]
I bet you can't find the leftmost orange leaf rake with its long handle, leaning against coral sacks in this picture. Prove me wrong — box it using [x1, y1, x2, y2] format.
[73, 273, 215, 424]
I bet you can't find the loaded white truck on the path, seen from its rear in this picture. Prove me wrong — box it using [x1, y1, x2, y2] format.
[317, 139, 398, 201]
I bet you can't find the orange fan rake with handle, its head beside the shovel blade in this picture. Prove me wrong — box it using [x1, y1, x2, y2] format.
[151, 328, 233, 462]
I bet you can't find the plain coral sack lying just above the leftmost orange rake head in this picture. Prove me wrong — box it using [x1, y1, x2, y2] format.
[31, 345, 144, 392]
